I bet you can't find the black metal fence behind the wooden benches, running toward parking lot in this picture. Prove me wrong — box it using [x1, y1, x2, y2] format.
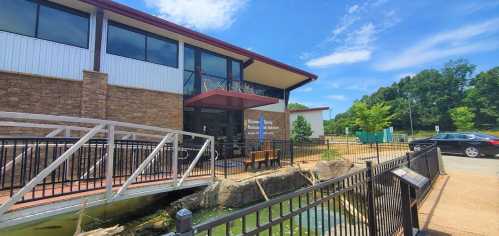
[215, 139, 409, 178]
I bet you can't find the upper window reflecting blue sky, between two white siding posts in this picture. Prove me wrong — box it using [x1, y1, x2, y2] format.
[107, 21, 178, 67]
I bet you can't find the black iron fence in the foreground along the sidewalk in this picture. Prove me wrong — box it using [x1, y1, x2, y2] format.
[172, 145, 439, 235]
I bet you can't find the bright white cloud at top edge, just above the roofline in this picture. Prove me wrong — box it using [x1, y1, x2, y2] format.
[145, 0, 247, 31]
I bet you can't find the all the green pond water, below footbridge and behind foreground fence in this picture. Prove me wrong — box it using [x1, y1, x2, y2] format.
[0, 193, 365, 236]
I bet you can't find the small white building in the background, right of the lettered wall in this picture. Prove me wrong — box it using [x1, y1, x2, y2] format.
[289, 107, 329, 138]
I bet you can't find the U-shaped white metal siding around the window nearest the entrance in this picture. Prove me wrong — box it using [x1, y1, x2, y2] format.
[101, 19, 183, 94]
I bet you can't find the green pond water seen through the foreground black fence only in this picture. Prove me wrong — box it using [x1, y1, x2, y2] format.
[193, 192, 366, 235]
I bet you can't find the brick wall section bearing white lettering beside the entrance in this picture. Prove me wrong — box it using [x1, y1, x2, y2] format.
[244, 109, 289, 139]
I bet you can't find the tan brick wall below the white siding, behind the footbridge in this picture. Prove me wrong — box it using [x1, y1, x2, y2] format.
[0, 71, 183, 136]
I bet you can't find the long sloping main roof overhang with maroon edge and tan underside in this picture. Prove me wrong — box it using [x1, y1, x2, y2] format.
[78, 0, 317, 90]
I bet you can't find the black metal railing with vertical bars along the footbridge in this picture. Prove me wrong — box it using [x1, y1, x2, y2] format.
[0, 138, 212, 203]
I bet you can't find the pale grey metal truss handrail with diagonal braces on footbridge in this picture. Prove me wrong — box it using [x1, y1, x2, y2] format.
[0, 111, 215, 219]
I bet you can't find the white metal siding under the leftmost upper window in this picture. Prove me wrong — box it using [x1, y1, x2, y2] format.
[0, 14, 95, 80]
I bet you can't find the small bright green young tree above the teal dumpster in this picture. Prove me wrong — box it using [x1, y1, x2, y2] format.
[352, 102, 392, 132]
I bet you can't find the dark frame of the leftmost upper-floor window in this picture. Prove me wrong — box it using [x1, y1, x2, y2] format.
[0, 0, 91, 49]
